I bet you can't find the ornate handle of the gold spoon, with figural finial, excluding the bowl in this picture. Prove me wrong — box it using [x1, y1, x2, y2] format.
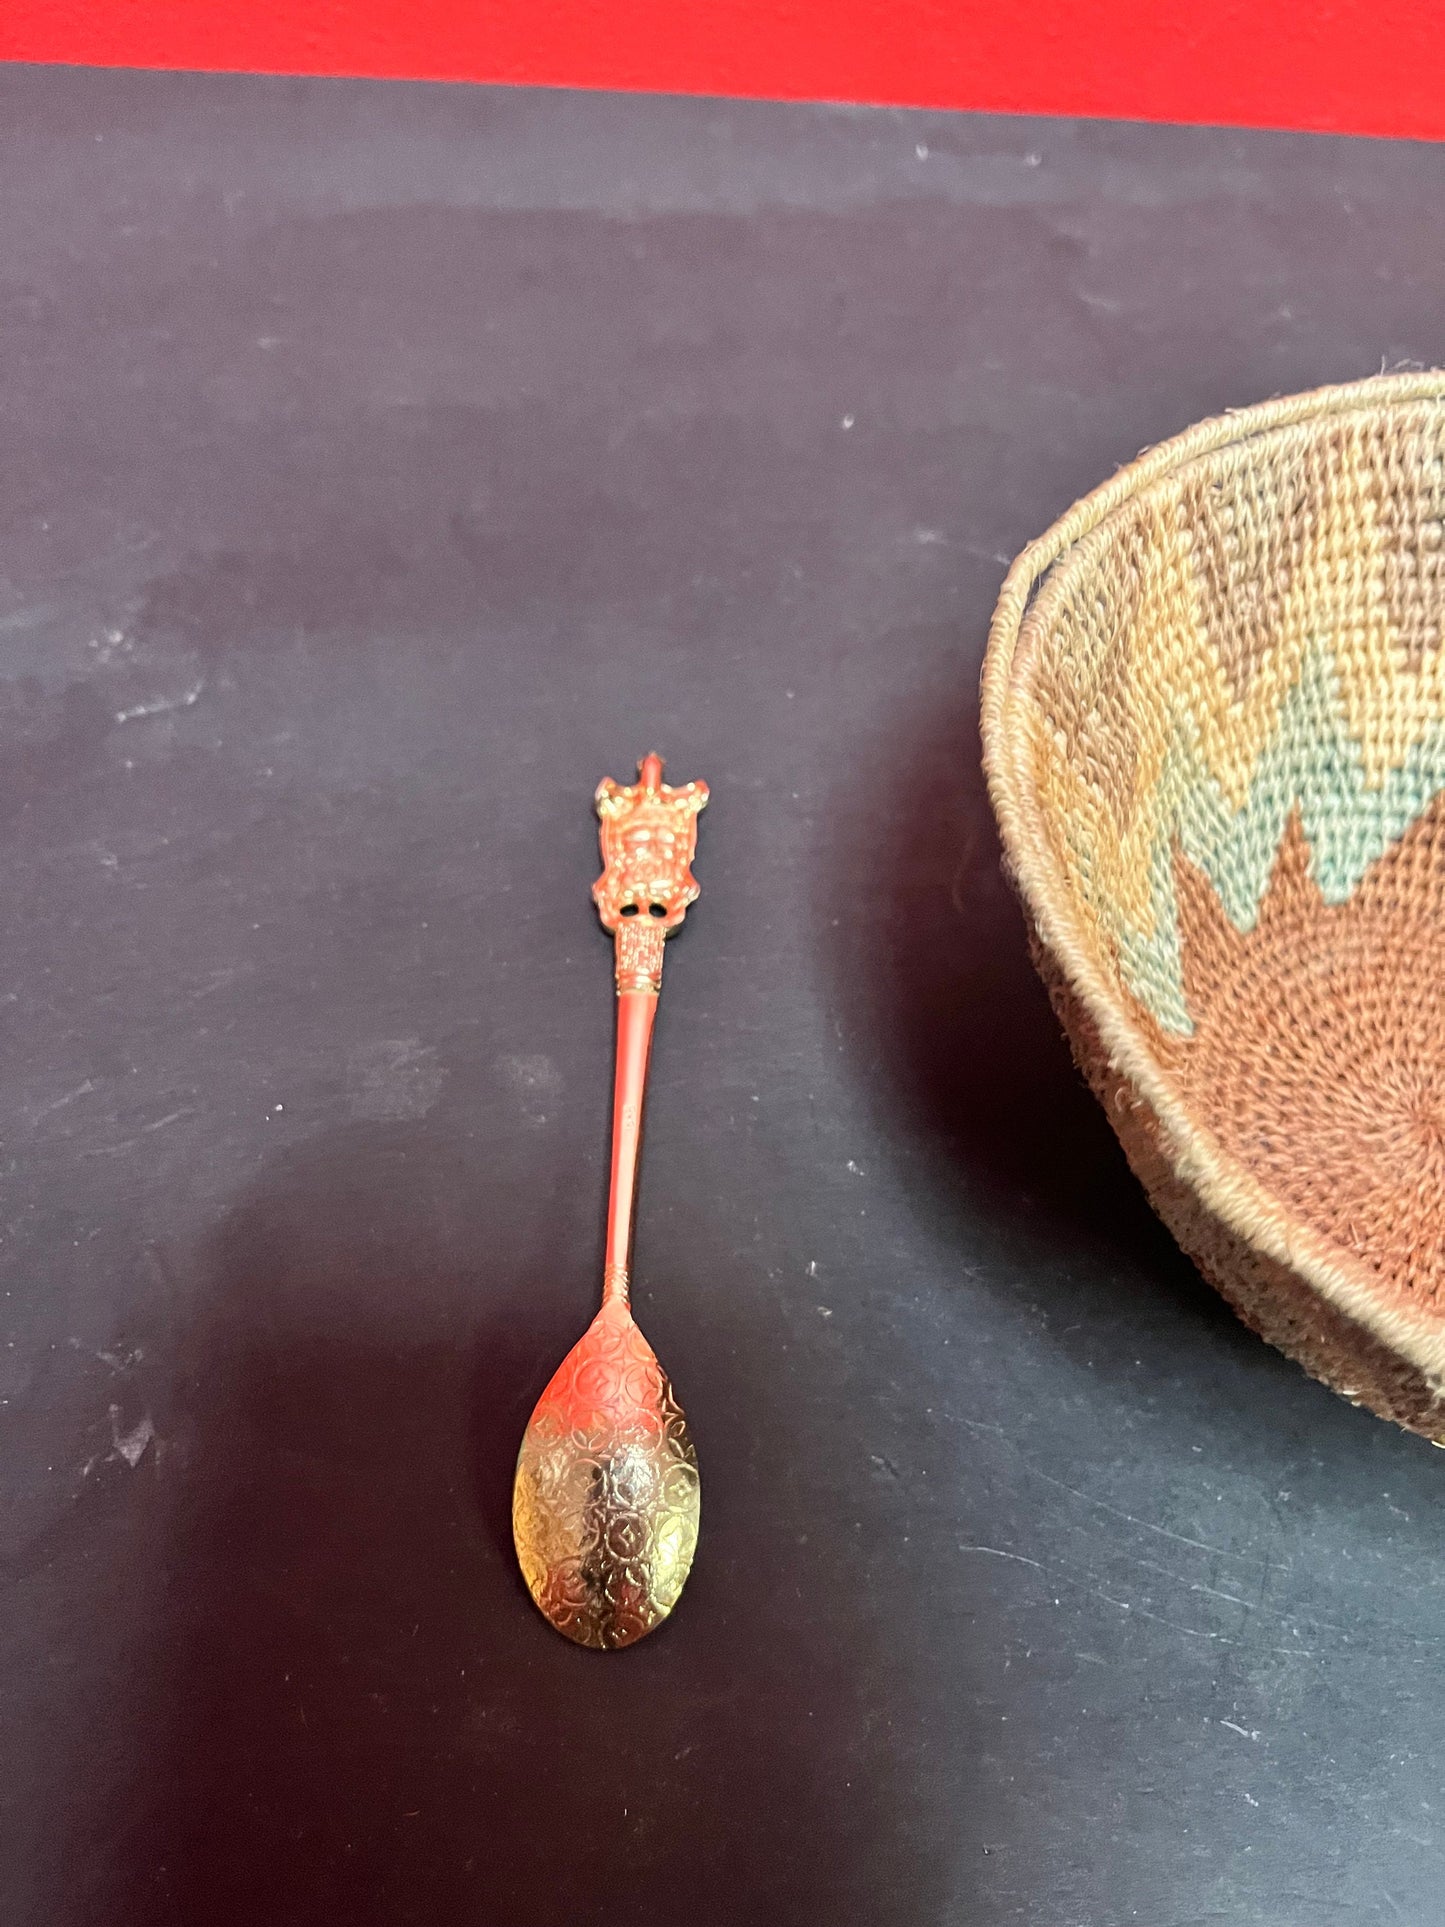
[591, 755, 707, 1307]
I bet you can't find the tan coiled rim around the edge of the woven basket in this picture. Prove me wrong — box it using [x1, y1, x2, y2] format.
[981, 368, 1445, 1397]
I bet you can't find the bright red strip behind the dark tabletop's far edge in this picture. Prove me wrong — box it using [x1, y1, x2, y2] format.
[0, 0, 1445, 137]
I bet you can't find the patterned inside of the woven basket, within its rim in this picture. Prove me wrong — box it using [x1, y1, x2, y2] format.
[1017, 401, 1445, 1310]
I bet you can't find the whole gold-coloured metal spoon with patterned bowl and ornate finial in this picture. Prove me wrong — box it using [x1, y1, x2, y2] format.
[512, 755, 707, 1650]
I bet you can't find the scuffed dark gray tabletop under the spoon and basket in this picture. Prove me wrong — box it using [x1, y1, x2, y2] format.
[0, 60, 1445, 1927]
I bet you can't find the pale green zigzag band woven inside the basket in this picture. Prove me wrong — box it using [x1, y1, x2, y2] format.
[1071, 644, 1445, 1037]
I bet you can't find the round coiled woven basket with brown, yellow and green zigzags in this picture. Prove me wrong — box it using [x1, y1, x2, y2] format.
[983, 374, 1445, 1443]
